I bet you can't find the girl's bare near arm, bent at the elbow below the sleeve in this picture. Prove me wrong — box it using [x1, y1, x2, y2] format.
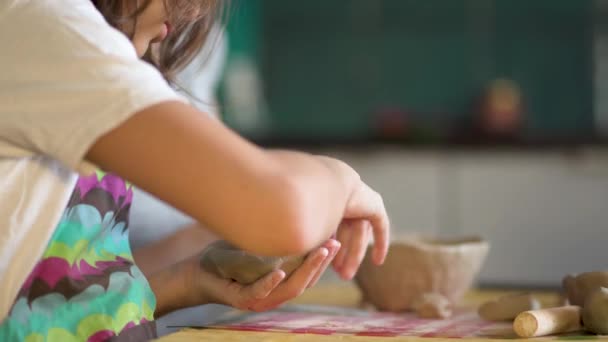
[87, 102, 388, 255]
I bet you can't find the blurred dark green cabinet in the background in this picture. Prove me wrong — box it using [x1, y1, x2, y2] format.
[224, 0, 594, 140]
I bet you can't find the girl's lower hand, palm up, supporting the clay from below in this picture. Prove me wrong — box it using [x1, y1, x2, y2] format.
[191, 239, 340, 312]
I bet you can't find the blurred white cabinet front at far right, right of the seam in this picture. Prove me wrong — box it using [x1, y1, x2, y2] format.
[455, 153, 608, 286]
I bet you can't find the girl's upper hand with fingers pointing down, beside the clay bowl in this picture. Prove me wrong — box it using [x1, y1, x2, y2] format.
[333, 182, 389, 280]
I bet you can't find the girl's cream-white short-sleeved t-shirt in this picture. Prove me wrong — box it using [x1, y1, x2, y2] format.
[0, 0, 185, 321]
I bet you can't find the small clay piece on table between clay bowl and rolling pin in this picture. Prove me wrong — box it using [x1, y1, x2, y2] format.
[477, 293, 540, 321]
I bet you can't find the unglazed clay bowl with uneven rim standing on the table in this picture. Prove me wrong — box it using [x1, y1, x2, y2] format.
[355, 235, 489, 312]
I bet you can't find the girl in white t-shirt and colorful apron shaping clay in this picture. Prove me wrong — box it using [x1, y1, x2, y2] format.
[0, 0, 389, 341]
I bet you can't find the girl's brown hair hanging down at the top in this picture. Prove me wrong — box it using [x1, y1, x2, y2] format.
[92, 0, 230, 83]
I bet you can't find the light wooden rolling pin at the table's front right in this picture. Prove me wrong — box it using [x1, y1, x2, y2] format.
[513, 305, 583, 338]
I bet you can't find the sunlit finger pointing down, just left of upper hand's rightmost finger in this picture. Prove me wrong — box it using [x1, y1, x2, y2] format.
[338, 220, 371, 280]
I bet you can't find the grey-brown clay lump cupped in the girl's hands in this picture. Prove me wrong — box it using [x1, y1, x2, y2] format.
[200, 240, 305, 285]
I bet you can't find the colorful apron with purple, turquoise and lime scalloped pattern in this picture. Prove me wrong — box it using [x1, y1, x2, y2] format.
[0, 172, 156, 342]
